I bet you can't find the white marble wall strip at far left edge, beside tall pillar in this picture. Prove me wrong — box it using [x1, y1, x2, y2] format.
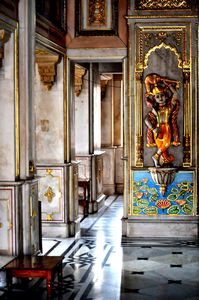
[0, 33, 16, 181]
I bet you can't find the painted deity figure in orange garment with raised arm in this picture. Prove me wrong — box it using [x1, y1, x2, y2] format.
[145, 74, 180, 167]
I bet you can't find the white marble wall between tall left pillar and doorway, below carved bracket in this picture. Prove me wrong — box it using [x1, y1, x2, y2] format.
[35, 59, 64, 164]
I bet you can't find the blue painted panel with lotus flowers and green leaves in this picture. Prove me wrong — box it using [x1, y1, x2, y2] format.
[129, 171, 196, 216]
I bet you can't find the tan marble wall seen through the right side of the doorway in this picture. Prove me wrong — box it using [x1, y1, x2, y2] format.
[101, 75, 124, 195]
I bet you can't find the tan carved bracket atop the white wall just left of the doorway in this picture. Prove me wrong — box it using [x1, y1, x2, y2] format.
[36, 50, 59, 91]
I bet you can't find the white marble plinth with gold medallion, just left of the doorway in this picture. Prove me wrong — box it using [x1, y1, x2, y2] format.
[37, 162, 80, 238]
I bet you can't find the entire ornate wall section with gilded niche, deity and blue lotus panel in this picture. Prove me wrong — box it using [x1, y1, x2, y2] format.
[125, 10, 198, 237]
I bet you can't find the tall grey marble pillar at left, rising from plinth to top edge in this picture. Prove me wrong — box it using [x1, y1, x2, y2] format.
[18, 0, 36, 179]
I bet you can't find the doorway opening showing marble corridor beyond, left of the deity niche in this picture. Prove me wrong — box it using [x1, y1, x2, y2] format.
[70, 61, 124, 219]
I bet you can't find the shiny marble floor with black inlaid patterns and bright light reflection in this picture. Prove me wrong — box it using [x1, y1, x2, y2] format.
[1, 196, 199, 300]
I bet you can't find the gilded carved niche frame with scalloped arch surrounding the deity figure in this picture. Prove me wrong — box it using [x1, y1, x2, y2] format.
[135, 24, 192, 167]
